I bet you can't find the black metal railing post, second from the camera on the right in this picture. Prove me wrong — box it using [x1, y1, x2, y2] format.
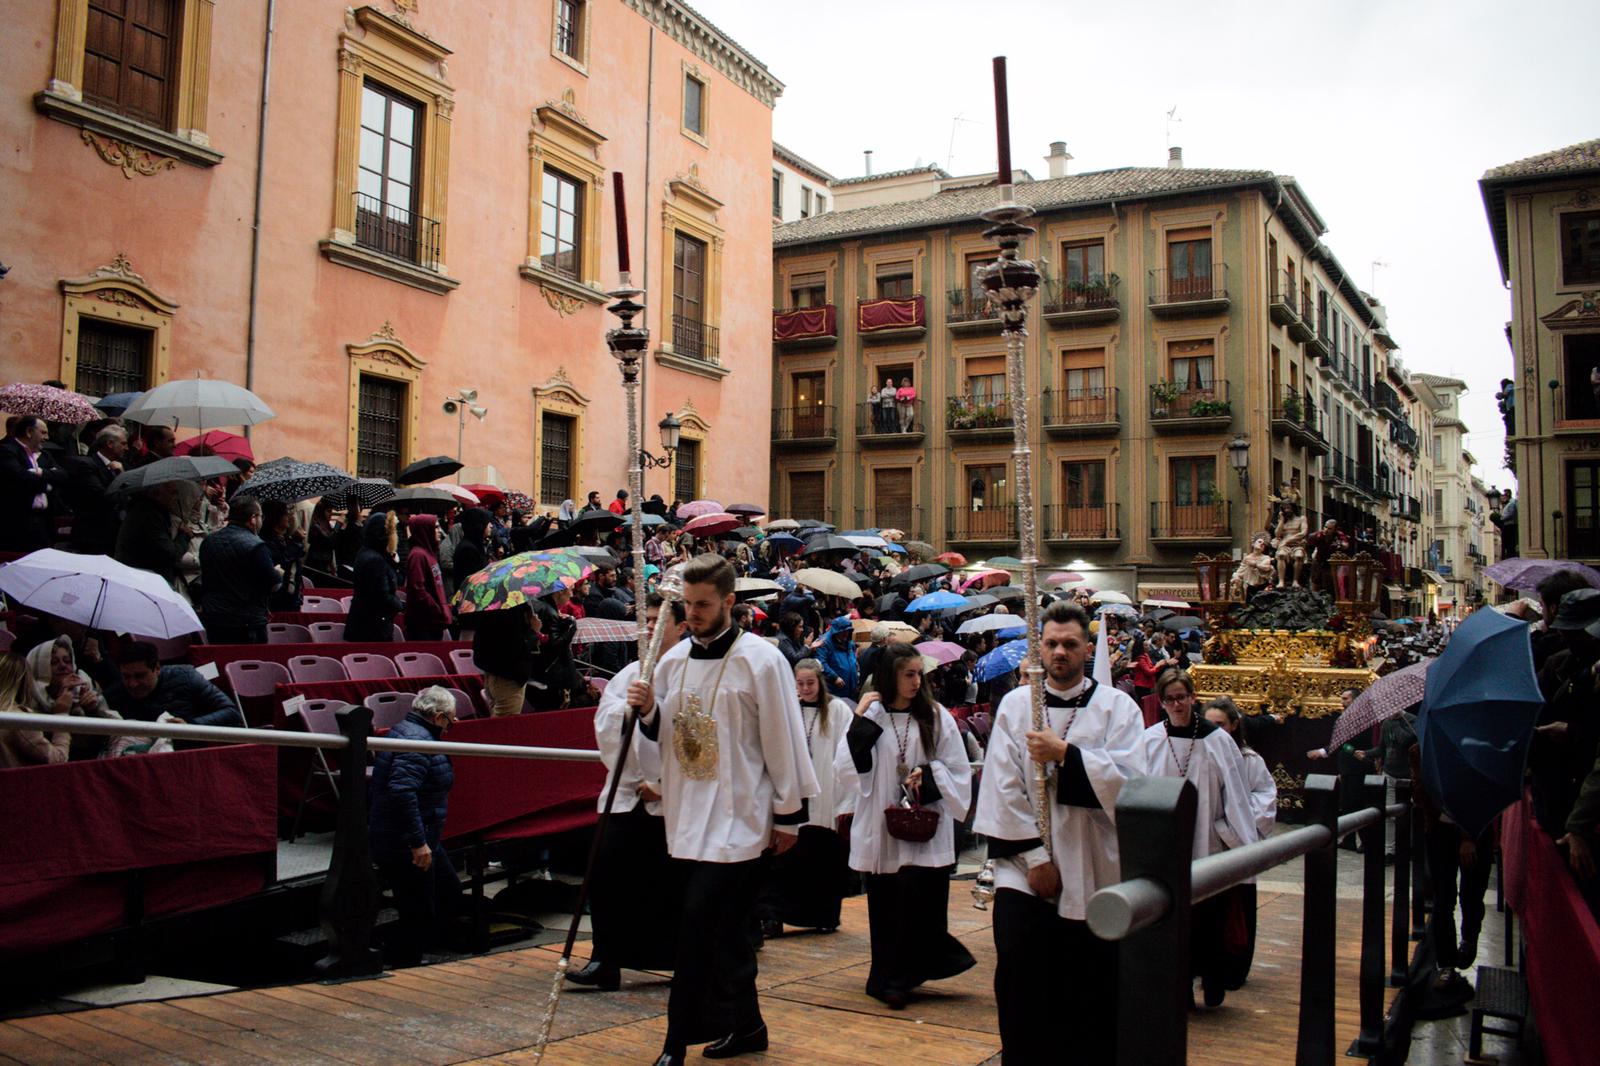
[1299, 773, 1339, 1066]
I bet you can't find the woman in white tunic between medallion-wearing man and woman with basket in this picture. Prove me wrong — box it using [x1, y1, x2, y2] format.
[755, 659, 854, 936]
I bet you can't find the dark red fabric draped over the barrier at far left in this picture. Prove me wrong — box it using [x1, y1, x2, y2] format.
[0, 744, 277, 954]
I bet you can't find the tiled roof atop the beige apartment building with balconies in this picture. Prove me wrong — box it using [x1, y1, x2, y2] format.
[773, 166, 1274, 248]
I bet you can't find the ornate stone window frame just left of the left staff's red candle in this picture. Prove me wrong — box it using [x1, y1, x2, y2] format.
[517, 98, 606, 315]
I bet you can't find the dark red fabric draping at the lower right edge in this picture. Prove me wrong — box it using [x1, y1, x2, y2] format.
[1501, 797, 1600, 1066]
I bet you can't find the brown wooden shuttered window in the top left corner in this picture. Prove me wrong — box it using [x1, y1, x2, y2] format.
[83, 0, 179, 130]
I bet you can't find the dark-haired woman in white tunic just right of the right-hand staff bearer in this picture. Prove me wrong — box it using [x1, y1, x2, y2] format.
[1139, 667, 1256, 1007]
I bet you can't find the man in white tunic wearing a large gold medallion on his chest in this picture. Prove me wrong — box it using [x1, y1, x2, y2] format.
[629, 554, 818, 1066]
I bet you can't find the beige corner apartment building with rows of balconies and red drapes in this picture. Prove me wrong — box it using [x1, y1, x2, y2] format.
[771, 146, 1426, 610]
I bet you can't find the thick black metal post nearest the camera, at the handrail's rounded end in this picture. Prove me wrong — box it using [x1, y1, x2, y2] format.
[1117, 778, 1195, 1066]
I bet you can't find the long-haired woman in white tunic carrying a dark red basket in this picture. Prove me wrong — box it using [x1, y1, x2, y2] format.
[834, 643, 976, 1010]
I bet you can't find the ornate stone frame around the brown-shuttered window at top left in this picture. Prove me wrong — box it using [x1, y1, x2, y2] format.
[34, 0, 222, 168]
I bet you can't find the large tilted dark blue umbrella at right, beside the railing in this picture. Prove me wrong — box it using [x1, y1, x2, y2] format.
[1416, 598, 1544, 837]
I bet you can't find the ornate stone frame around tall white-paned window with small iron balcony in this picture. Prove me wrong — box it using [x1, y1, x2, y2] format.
[317, 6, 461, 295]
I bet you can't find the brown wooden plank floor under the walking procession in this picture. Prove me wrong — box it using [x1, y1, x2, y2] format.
[0, 882, 1360, 1066]
